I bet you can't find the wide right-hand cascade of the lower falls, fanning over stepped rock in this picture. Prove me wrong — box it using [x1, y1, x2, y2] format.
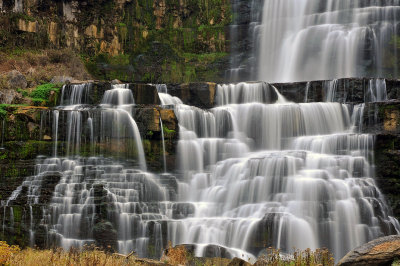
[156, 80, 400, 259]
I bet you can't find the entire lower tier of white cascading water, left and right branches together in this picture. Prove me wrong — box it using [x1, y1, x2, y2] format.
[3, 79, 400, 258]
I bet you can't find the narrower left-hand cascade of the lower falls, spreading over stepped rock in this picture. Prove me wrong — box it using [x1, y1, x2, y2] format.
[3, 84, 169, 256]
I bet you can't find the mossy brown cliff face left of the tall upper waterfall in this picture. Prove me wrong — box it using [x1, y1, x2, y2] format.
[0, 0, 232, 83]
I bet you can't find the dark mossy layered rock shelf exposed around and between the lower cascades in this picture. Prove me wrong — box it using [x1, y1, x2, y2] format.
[0, 79, 400, 257]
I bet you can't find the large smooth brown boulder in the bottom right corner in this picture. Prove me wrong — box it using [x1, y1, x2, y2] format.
[338, 236, 400, 266]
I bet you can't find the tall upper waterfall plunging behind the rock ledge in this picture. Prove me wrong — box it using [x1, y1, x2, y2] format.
[257, 0, 400, 82]
